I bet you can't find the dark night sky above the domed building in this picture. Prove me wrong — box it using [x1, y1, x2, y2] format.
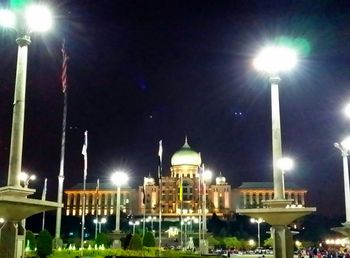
[0, 0, 350, 219]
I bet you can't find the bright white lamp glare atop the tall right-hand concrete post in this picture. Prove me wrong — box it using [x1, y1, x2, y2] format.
[253, 46, 297, 73]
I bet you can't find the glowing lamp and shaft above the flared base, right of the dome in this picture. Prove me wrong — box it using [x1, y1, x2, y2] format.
[253, 46, 297, 200]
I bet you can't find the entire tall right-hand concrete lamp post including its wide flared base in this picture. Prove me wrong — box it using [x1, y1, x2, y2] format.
[237, 46, 316, 258]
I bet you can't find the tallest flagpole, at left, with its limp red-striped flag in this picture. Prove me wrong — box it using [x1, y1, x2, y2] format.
[55, 41, 69, 243]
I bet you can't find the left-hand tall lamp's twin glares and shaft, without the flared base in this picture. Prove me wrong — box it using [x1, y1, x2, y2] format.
[0, 5, 52, 187]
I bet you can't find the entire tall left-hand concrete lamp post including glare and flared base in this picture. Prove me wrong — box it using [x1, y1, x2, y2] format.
[0, 4, 62, 258]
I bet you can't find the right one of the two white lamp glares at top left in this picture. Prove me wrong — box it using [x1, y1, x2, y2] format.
[26, 5, 52, 32]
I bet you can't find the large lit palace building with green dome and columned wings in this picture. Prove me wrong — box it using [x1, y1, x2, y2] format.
[65, 138, 307, 220]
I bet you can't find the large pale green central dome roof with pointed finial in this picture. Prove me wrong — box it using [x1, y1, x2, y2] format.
[171, 137, 202, 166]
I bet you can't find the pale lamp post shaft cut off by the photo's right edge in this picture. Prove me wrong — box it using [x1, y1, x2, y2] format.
[334, 137, 350, 223]
